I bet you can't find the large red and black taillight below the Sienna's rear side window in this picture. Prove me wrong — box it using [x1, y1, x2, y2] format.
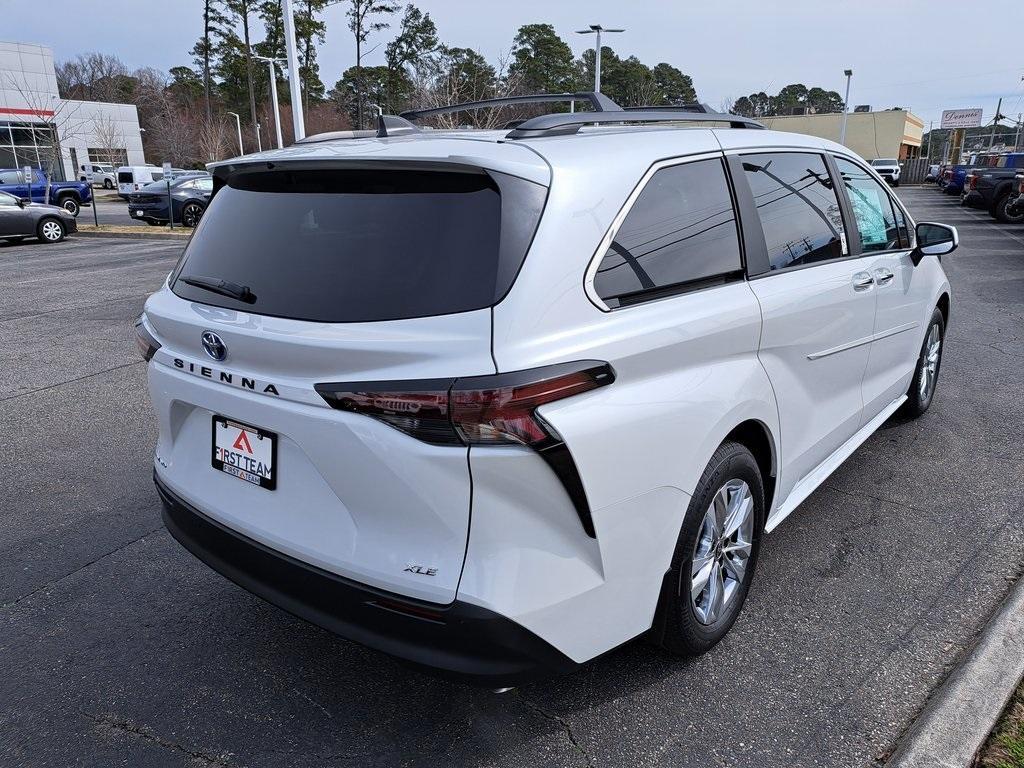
[316, 360, 615, 537]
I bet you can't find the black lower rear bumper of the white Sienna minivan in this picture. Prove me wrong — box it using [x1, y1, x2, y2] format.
[154, 474, 578, 687]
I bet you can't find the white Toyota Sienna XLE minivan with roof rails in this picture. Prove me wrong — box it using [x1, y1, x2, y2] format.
[136, 94, 957, 687]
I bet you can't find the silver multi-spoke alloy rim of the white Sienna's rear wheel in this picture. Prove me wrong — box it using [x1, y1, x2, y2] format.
[690, 479, 754, 625]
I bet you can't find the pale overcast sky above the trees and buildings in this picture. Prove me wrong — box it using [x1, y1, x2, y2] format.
[0, 0, 1024, 125]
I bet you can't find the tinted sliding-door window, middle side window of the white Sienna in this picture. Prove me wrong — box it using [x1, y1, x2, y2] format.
[742, 153, 845, 269]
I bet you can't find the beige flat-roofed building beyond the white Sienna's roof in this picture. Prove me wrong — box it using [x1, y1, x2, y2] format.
[759, 110, 925, 160]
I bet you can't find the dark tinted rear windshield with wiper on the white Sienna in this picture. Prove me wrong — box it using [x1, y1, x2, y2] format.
[172, 170, 546, 323]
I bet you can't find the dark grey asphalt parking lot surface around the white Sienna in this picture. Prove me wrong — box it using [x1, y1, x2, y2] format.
[0, 187, 1024, 768]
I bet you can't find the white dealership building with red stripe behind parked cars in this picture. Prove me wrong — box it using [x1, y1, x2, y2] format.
[0, 41, 145, 181]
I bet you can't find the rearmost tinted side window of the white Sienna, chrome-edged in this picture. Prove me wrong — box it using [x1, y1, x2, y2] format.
[594, 160, 742, 307]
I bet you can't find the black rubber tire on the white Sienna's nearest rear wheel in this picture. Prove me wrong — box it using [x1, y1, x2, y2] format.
[649, 442, 765, 655]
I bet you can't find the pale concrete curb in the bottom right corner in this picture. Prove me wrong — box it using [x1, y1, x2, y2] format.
[885, 578, 1024, 768]
